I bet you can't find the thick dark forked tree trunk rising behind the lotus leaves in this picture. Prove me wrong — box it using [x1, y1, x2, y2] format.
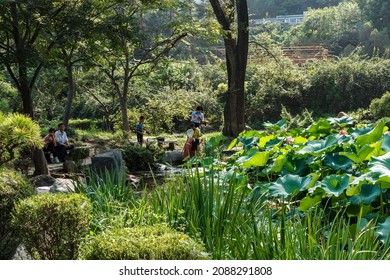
[210, 0, 249, 137]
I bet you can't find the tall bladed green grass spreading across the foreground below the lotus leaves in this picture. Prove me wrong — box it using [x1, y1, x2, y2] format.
[76, 168, 390, 260]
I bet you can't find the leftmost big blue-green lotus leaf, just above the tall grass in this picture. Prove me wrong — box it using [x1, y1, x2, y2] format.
[269, 174, 313, 198]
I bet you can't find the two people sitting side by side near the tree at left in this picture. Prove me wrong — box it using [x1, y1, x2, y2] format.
[43, 123, 72, 163]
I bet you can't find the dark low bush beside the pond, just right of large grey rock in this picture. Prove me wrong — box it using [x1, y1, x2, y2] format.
[122, 143, 165, 171]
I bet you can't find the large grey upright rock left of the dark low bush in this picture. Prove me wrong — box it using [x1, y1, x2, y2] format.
[92, 150, 123, 181]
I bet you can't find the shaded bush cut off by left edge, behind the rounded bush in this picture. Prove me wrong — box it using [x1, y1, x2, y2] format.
[0, 169, 34, 259]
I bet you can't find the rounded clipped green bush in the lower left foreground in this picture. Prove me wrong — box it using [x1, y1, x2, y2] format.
[12, 193, 92, 260]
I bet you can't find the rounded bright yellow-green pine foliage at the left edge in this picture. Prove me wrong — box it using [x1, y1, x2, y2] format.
[0, 113, 43, 166]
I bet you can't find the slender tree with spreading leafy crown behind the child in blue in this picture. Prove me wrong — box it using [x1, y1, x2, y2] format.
[96, 1, 189, 132]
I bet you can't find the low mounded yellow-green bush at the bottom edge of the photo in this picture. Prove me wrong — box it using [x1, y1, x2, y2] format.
[80, 225, 208, 260]
